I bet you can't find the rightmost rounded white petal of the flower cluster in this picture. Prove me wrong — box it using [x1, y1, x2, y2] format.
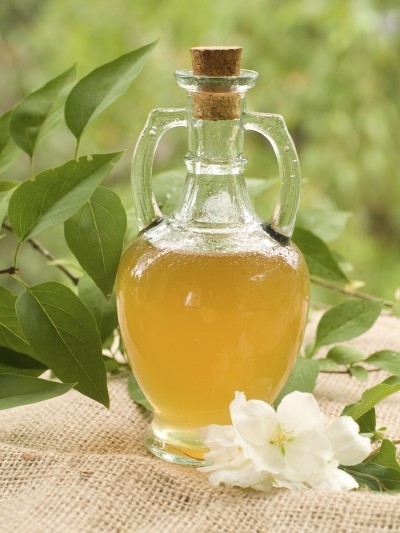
[326, 416, 372, 465]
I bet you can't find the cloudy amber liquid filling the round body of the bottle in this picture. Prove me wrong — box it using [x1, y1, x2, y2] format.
[117, 239, 309, 445]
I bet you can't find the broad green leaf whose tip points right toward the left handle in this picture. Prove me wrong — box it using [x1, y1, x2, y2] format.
[8, 152, 122, 241]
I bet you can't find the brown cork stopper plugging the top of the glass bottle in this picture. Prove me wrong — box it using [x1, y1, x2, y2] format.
[190, 46, 242, 120]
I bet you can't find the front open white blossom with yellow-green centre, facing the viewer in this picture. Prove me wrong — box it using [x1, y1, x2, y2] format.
[230, 392, 332, 483]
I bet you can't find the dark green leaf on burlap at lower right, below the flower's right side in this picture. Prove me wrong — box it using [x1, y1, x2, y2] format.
[340, 463, 400, 493]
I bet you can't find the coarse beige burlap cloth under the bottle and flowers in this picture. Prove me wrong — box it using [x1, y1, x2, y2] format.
[0, 317, 400, 533]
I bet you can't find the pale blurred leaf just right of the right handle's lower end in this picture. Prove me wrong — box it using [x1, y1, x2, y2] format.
[296, 207, 352, 242]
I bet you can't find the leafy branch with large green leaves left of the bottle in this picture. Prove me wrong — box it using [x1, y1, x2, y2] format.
[0, 43, 155, 409]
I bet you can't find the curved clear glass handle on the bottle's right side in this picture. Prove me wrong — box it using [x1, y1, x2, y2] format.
[243, 111, 301, 243]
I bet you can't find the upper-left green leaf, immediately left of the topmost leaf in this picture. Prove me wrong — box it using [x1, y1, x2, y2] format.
[10, 66, 76, 157]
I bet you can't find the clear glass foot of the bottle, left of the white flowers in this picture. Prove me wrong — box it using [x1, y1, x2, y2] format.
[144, 426, 213, 466]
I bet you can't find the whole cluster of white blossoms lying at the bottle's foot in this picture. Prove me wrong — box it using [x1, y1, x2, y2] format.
[200, 392, 371, 490]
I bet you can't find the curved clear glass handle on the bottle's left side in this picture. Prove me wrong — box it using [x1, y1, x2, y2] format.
[132, 109, 187, 229]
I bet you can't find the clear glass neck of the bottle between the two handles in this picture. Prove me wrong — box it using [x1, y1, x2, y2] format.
[173, 92, 258, 229]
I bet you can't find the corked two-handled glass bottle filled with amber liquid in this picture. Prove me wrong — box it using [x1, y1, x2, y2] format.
[117, 47, 309, 464]
